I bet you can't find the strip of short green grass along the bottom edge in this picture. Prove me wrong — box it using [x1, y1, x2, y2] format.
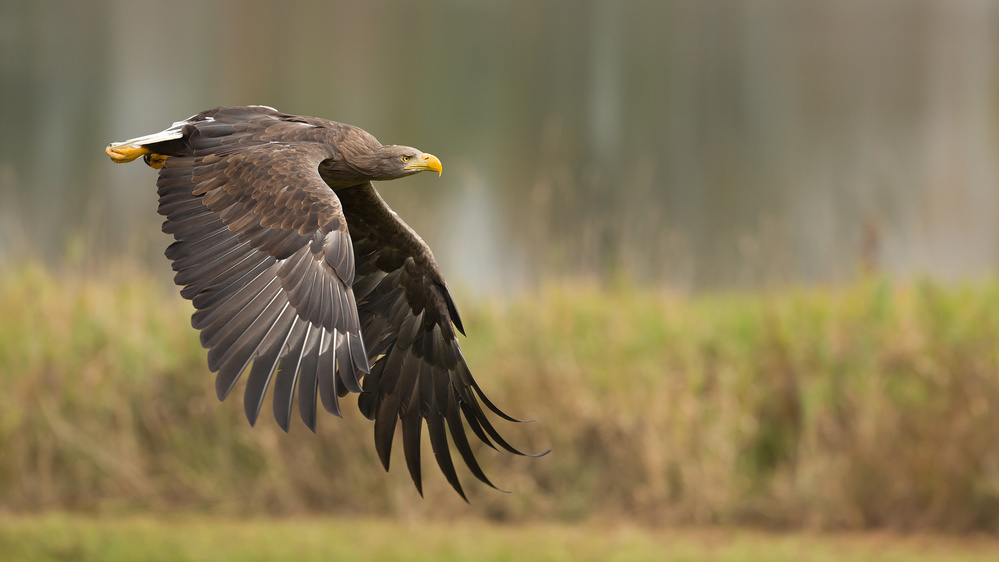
[0, 514, 999, 562]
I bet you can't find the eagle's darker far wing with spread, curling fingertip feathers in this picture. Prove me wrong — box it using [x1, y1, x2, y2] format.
[339, 183, 544, 492]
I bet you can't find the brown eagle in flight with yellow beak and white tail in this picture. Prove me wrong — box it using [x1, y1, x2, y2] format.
[105, 105, 545, 494]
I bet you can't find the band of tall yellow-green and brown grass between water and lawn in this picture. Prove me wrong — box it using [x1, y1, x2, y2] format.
[0, 266, 999, 533]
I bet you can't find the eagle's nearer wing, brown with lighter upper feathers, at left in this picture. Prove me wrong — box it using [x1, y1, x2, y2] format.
[153, 108, 370, 431]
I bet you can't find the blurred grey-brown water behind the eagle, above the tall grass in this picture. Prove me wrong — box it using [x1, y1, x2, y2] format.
[0, 0, 999, 292]
